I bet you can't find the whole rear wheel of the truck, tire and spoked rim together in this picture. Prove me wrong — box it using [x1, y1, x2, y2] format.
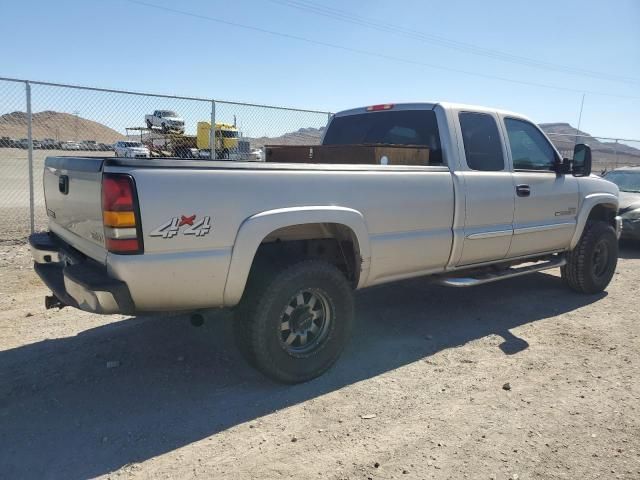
[234, 260, 353, 383]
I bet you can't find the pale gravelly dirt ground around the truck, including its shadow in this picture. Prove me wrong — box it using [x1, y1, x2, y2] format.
[0, 245, 640, 479]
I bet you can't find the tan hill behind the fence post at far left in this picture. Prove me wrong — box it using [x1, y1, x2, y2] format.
[0, 110, 124, 143]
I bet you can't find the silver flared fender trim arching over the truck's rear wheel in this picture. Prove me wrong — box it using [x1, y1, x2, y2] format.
[224, 206, 371, 306]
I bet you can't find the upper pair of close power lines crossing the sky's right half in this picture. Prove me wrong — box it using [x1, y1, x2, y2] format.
[269, 0, 640, 84]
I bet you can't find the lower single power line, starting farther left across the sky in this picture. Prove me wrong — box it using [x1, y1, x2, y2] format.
[125, 0, 640, 100]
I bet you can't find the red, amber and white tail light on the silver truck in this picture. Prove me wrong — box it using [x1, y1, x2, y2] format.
[102, 173, 144, 254]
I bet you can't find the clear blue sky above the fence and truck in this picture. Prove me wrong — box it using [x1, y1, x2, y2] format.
[0, 0, 640, 138]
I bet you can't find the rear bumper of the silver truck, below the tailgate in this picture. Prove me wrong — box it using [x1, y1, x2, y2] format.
[29, 233, 135, 314]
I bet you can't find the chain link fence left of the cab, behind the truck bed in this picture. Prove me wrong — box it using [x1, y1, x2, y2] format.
[0, 79, 330, 243]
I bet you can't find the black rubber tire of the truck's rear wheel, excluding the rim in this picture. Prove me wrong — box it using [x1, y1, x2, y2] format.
[234, 260, 354, 383]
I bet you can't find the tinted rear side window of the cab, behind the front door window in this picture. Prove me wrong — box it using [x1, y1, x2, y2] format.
[459, 112, 504, 172]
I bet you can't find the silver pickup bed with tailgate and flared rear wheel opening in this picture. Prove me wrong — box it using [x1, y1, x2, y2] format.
[45, 157, 455, 309]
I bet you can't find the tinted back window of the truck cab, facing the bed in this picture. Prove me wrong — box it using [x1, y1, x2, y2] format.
[323, 110, 442, 165]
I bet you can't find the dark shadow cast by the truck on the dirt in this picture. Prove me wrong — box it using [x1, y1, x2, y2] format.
[0, 274, 606, 479]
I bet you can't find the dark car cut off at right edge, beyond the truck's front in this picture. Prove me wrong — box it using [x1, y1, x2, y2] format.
[603, 167, 640, 240]
